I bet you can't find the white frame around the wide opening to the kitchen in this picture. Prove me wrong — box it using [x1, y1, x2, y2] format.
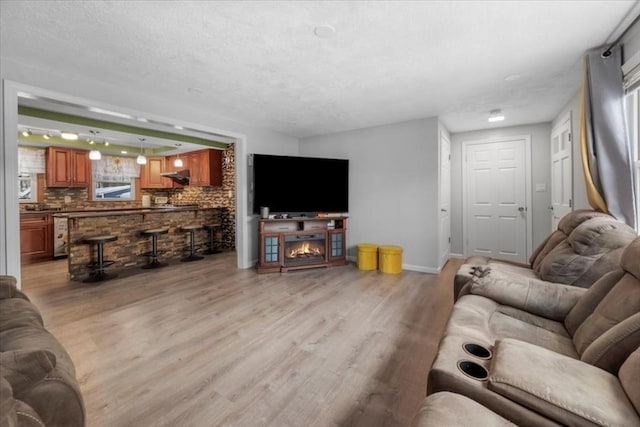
[0, 80, 249, 288]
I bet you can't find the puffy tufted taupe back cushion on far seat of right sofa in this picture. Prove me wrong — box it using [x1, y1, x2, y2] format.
[538, 217, 638, 288]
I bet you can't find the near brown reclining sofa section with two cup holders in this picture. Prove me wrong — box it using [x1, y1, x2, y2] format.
[427, 237, 640, 426]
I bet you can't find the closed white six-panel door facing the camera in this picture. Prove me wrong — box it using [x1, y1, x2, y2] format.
[463, 137, 530, 262]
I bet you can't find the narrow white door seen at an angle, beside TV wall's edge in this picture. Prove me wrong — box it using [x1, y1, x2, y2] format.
[439, 133, 451, 268]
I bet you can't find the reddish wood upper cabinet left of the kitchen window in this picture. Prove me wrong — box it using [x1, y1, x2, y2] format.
[46, 147, 91, 187]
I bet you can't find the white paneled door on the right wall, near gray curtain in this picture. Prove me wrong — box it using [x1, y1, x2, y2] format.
[551, 116, 573, 230]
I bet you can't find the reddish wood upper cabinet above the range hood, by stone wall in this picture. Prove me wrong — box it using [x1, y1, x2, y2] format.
[166, 149, 222, 188]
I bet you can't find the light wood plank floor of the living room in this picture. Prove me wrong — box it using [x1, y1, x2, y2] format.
[22, 253, 459, 427]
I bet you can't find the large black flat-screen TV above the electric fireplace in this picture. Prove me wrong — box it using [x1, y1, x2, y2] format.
[252, 154, 349, 216]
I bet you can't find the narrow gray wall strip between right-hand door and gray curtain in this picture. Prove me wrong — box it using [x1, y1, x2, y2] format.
[551, 91, 590, 214]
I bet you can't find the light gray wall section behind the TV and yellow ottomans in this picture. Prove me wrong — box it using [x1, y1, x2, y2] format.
[300, 117, 439, 272]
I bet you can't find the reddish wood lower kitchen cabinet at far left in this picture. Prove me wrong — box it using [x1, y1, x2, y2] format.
[20, 213, 53, 264]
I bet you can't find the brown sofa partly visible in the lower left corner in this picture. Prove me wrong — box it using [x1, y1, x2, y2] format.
[0, 276, 86, 427]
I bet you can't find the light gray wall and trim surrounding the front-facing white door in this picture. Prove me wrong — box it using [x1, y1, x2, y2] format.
[451, 123, 551, 255]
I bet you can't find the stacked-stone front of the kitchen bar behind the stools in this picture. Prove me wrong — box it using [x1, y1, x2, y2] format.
[66, 207, 222, 280]
